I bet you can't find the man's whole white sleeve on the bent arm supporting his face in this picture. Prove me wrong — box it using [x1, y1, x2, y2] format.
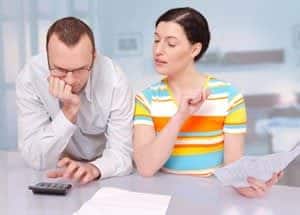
[16, 68, 76, 169]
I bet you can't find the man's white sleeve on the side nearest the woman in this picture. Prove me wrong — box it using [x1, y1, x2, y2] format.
[91, 68, 134, 179]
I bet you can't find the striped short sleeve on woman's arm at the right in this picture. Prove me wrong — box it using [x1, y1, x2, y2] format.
[223, 86, 247, 134]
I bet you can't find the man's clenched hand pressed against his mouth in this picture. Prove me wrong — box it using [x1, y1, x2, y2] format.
[48, 76, 80, 123]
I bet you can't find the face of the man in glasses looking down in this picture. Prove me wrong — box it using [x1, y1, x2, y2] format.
[48, 34, 95, 94]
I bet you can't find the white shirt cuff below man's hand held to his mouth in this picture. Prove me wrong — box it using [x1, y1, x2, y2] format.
[52, 110, 77, 138]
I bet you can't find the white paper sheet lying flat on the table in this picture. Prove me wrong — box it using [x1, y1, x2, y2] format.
[73, 187, 171, 215]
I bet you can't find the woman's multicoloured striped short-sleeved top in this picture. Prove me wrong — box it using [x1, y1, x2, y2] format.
[134, 76, 247, 176]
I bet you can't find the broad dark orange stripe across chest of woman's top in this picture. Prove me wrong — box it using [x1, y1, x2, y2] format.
[153, 116, 225, 132]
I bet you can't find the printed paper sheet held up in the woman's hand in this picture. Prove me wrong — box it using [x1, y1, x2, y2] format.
[214, 144, 300, 187]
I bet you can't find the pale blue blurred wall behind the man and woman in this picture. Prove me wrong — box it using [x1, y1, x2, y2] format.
[0, 0, 300, 149]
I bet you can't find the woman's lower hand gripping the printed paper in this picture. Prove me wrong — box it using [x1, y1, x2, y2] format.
[234, 171, 283, 198]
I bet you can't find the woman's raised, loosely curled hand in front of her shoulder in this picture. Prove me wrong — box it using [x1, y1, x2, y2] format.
[178, 90, 210, 118]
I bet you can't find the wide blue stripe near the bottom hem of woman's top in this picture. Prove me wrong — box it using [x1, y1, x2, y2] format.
[164, 150, 224, 171]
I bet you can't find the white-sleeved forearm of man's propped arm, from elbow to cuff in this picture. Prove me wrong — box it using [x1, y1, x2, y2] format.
[18, 111, 76, 169]
